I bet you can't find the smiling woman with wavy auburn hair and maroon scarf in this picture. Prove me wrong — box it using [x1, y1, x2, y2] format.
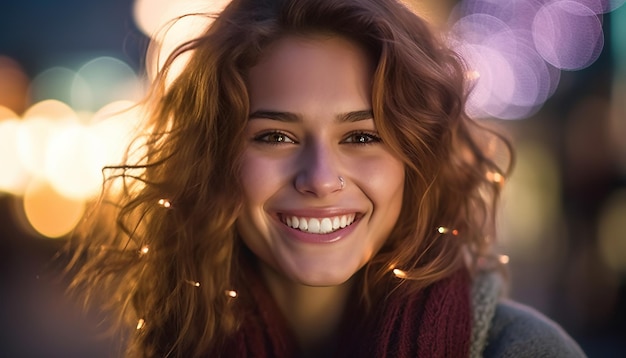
[67, 0, 583, 357]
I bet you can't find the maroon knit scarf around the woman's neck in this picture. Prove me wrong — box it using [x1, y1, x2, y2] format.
[221, 270, 471, 358]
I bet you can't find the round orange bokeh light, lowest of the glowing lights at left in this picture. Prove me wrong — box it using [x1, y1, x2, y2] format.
[23, 181, 85, 238]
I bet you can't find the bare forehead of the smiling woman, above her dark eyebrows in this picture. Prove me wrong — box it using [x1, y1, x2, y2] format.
[248, 35, 373, 110]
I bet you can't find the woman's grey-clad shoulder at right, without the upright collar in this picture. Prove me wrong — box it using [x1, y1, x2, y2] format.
[483, 300, 585, 357]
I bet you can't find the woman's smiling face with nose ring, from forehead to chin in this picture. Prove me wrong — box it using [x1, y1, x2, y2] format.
[237, 37, 404, 286]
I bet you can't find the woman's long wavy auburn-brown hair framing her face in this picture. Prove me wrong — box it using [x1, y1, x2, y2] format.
[63, 0, 512, 357]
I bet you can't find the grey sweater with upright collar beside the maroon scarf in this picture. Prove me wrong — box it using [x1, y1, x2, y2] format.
[470, 272, 585, 358]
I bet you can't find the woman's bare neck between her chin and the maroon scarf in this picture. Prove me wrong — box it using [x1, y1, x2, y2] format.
[262, 267, 354, 357]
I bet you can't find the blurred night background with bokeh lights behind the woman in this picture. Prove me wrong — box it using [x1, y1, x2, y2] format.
[0, 0, 626, 357]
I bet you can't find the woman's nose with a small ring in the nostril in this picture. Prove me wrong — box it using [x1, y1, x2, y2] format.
[294, 143, 346, 197]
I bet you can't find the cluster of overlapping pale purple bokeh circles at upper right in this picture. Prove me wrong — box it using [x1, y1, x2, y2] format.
[450, 0, 624, 119]
